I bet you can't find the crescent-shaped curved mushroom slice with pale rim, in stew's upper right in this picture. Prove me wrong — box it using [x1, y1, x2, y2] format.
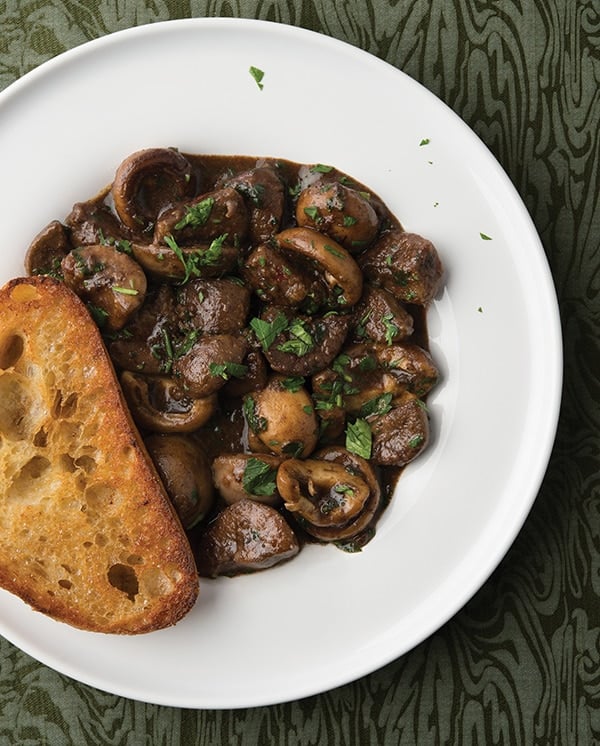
[276, 227, 363, 308]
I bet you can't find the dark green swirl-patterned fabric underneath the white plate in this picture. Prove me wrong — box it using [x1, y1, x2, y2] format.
[0, 0, 600, 746]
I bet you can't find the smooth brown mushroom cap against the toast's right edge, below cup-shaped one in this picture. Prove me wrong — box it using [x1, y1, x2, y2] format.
[145, 435, 214, 530]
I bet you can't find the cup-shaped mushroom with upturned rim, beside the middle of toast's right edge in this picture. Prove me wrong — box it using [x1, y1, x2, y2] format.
[120, 371, 217, 433]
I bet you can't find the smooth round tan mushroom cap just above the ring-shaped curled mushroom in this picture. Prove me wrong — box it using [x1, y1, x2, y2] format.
[244, 376, 318, 458]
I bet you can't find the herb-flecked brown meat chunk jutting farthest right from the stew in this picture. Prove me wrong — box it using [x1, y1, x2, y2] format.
[358, 227, 443, 305]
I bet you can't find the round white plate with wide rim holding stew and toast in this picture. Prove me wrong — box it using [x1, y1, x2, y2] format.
[0, 19, 562, 708]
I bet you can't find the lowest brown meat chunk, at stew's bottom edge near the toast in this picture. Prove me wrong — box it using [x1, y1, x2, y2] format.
[196, 500, 300, 578]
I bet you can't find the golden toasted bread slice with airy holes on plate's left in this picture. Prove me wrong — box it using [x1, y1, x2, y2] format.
[0, 277, 198, 634]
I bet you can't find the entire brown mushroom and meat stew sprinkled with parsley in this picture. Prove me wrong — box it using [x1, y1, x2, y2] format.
[25, 148, 443, 576]
